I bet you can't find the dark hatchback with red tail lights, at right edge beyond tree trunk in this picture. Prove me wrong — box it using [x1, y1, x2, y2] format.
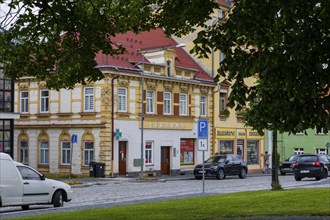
[293, 154, 330, 181]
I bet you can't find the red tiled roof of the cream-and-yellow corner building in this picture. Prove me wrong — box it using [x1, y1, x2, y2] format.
[96, 28, 213, 81]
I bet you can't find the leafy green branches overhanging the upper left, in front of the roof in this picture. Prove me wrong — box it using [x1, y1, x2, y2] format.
[0, 0, 216, 89]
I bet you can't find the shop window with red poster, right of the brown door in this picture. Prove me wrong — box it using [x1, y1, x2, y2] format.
[180, 138, 195, 165]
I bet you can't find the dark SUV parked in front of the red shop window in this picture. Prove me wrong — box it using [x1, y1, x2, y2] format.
[194, 154, 248, 180]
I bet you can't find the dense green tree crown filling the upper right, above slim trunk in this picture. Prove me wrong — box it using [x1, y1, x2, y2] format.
[193, 0, 330, 135]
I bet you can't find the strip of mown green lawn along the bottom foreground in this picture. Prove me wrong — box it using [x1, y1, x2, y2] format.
[10, 188, 330, 220]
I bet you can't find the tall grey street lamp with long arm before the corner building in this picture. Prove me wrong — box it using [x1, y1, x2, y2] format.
[139, 43, 186, 178]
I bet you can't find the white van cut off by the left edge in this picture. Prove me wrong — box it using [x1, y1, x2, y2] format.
[0, 152, 73, 210]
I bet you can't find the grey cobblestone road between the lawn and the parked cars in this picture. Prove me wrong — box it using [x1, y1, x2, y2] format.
[0, 175, 330, 219]
